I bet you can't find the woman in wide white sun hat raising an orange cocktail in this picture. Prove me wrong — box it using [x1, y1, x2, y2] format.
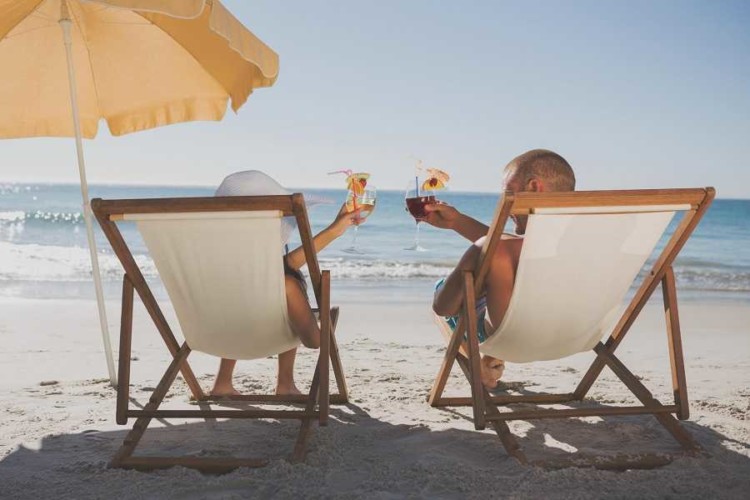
[211, 170, 360, 396]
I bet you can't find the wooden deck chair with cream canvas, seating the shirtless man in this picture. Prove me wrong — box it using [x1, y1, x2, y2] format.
[428, 188, 714, 469]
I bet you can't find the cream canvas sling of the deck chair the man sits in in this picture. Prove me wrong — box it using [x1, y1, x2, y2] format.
[479, 205, 690, 363]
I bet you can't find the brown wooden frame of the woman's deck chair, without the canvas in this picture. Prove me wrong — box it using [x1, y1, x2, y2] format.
[91, 193, 348, 472]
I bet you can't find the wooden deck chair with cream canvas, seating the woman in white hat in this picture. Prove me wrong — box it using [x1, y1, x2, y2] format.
[91, 194, 348, 472]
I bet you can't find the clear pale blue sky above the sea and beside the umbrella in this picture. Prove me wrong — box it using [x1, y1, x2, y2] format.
[0, 0, 750, 198]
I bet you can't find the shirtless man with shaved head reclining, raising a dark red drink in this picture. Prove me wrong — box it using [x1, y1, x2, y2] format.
[425, 149, 575, 389]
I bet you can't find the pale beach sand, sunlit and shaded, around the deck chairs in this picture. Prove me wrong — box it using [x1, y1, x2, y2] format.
[0, 287, 750, 499]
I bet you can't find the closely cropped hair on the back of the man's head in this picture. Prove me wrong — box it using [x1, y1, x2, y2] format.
[505, 149, 576, 191]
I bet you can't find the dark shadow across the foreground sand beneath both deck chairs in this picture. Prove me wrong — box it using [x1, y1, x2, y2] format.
[0, 392, 750, 498]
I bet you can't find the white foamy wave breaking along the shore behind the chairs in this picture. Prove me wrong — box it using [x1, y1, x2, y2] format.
[0, 242, 750, 292]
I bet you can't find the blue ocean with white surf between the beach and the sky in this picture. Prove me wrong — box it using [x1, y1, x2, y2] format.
[0, 184, 750, 303]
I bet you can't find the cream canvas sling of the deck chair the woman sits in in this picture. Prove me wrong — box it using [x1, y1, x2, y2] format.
[131, 211, 300, 359]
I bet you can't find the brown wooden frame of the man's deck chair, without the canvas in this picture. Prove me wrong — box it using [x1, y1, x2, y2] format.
[428, 187, 715, 469]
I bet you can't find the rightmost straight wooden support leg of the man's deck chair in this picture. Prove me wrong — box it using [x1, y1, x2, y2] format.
[661, 266, 690, 420]
